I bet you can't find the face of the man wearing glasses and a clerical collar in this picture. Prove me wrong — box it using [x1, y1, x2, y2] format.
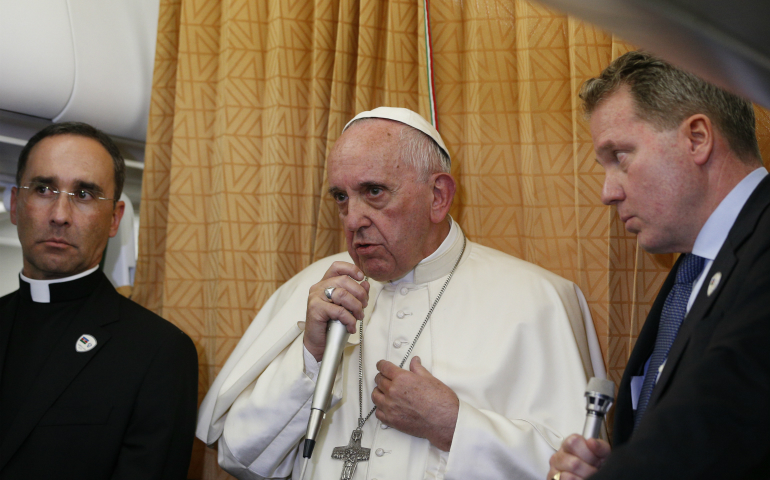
[11, 134, 123, 279]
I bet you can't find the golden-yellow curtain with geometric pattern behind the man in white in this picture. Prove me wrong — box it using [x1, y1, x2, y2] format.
[133, 0, 770, 479]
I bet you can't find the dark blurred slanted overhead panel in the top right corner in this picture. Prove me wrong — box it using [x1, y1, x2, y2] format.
[538, 0, 770, 107]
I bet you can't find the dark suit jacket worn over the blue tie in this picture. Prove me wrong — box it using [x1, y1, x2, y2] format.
[591, 176, 770, 480]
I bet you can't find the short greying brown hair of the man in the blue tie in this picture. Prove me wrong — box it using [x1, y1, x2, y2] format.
[580, 52, 762, 164]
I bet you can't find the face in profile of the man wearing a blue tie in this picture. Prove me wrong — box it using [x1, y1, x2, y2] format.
[590, 87, 702, 253]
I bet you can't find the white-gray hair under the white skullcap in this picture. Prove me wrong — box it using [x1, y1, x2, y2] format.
[347, 118, 452, 183]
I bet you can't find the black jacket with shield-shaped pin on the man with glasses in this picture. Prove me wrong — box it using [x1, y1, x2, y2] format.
[0, 272, 198, 480]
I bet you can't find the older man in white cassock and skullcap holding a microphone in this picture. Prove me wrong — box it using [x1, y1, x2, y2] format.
[197, 107, 604, 480]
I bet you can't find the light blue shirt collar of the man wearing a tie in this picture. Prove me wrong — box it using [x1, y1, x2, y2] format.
[692, 167, 767, 260]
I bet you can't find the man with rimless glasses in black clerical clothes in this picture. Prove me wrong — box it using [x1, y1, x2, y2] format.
[0, 123, 198, 480]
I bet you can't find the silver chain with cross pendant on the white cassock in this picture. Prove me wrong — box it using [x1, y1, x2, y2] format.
[332, 234, 467, 480]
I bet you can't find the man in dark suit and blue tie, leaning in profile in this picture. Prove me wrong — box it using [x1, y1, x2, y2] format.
[548, 52, 770, 480]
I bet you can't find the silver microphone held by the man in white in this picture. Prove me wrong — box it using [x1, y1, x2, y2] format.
[302, 320, 350, 458]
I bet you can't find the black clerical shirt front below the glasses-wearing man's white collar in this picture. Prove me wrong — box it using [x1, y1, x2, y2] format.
[0, 271, 99, 443]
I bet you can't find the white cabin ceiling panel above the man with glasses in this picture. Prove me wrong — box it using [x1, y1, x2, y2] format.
[0, 0, 160, 141]
